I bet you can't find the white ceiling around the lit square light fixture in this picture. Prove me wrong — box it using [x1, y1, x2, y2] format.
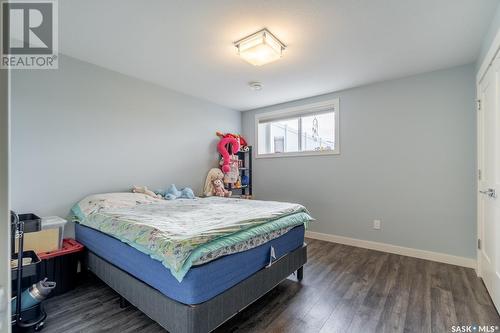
[59, 0, 499, 110]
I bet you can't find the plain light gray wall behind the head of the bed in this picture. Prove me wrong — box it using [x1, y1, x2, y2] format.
[12, 56, 241, 233]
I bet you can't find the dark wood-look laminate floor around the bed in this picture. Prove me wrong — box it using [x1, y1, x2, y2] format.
[44, 240, 500, 333]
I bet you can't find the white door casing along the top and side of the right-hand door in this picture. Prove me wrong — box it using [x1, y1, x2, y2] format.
[475, 28, 500, 277]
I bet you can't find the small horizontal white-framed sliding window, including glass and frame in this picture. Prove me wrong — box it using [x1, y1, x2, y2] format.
[255, 99, 339, 157]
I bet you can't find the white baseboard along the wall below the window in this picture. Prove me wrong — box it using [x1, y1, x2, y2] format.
[306, 231, 477, 269]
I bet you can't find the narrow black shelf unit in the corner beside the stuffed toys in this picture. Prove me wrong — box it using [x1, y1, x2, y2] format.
[224, 146, 253, 199]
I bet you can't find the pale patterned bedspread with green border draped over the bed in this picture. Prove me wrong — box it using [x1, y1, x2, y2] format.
[72, 193, 312, 282]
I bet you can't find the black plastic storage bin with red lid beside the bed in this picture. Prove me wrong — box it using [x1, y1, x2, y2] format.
[38, 239, 84, 298]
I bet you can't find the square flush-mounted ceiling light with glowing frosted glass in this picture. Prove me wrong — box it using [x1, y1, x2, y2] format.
[234, 29, 285, 66]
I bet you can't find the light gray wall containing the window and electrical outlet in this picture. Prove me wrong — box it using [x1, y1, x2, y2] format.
[242, 64, 476, 257]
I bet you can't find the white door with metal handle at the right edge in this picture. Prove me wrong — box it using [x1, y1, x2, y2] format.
[478, 58, 500, 309]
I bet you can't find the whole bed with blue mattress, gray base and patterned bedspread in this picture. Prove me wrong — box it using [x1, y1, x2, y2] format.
[72, 193, 312, 332]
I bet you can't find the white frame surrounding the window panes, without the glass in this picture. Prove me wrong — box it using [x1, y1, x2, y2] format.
[254, 98, 340, 158]
